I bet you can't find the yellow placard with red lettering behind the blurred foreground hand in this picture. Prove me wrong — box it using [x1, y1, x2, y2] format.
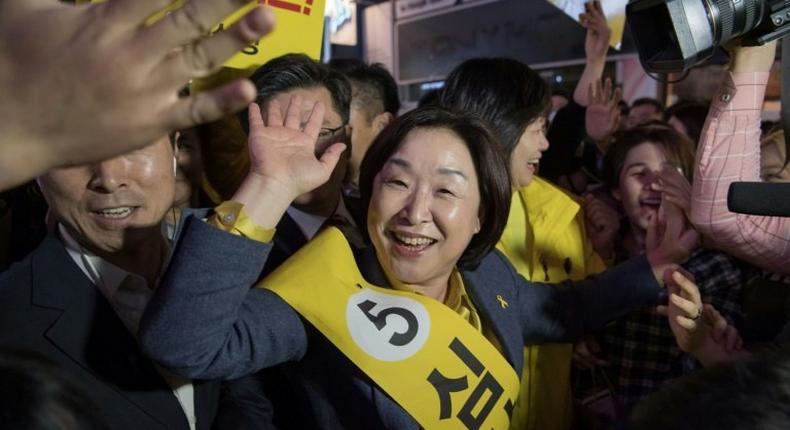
[77, 0, 326, 69]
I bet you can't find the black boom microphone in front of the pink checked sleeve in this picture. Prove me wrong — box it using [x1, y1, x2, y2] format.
[727, 182, 790, 217]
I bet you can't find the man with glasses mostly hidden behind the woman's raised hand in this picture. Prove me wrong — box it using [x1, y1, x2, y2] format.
[240, 54, 359, 276]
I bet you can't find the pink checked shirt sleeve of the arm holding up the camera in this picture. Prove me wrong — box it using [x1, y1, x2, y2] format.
[691, 73, 790, 273]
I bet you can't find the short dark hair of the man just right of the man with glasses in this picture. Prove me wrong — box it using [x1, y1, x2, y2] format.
[329, 59, 400, 121]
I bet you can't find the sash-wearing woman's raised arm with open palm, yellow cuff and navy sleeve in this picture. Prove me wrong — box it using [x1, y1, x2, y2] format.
[140, 97, 343, 379]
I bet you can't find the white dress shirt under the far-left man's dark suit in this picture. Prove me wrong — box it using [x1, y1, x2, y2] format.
[58, 225, 197, 430]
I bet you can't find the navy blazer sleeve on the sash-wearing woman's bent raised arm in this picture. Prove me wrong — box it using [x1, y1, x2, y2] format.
[140, 216, 307, 379]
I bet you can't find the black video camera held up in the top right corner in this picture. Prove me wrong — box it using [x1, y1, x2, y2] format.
[626, 0, 790, 73]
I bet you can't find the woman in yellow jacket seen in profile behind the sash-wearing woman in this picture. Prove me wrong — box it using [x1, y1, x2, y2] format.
[440, 58, 618, 430]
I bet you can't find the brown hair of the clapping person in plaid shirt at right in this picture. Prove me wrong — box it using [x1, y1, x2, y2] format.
[602, 121, 694, 190]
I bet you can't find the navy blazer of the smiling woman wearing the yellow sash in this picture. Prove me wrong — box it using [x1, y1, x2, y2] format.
[141, 218, 660, 429]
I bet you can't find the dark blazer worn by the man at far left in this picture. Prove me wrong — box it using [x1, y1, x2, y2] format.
[0, 235, 220, 430]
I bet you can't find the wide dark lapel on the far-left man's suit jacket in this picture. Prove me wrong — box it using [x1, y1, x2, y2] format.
[31, 235, 193, 429]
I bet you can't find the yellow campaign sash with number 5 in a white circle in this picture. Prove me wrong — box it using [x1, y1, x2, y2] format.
[263, 228, 519, 430]
